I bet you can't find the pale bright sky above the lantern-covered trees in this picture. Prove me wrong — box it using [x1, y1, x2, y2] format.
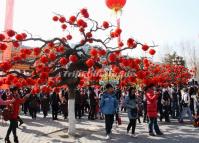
[0, 0, 199, 59]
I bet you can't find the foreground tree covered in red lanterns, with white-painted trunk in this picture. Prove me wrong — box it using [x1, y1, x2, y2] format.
[0, 8, 186, 134]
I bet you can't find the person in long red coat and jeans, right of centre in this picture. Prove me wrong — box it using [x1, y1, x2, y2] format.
[145, 84, 163, 136]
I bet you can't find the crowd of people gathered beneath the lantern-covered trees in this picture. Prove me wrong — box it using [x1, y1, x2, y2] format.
[0, 81, 199, 143]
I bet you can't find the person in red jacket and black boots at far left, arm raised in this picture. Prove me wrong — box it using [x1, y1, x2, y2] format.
[5, 87, 29, 143]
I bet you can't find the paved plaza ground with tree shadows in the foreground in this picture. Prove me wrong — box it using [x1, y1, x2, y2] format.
[0, 114, 199, 143]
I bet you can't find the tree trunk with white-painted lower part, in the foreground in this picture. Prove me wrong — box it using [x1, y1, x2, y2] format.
[68, 88, 76, 135]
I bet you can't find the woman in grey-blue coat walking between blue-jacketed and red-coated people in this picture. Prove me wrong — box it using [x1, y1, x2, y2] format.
[125, 87, 138, 137]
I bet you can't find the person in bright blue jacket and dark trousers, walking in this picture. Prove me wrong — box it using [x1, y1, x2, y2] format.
[100, 84, 118, 139]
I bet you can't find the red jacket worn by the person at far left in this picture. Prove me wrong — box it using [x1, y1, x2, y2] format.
[11, 98, 25, 120]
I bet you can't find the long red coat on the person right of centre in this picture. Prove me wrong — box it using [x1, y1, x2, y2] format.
[146, 90, 158, 118]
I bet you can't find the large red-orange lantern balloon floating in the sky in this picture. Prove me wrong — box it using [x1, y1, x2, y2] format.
[106, 0, 126, 12]
